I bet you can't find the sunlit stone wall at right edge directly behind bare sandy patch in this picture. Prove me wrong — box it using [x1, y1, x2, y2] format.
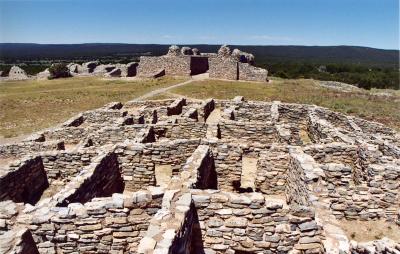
[322, 164, 400, 223]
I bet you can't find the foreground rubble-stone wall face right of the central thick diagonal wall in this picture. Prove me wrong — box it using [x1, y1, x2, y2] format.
[192, 190, 323, 253]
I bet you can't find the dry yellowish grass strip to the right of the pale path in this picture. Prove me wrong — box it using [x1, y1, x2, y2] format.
[171, 79, 400, 130]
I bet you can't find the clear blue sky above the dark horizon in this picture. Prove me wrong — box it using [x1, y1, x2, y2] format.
[0, 0, 399, 49]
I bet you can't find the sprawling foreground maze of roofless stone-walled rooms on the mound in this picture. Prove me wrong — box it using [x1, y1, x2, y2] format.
[0, 97, 400, 254]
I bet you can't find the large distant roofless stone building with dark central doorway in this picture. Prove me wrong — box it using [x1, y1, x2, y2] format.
[138, 45, 268, 82]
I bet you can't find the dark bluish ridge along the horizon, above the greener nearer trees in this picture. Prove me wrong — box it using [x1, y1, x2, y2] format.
[0, 43, 399, 67]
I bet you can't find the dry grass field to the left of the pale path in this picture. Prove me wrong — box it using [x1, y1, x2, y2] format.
[0, 77, 184, 138]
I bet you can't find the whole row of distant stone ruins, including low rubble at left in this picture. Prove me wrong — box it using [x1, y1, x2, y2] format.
[2, 45, 268, 82]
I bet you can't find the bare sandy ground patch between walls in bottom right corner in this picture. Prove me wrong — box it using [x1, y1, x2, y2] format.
[340, 220, 400, 242]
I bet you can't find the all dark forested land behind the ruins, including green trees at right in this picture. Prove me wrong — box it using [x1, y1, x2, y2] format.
[0, 43, 400, 89]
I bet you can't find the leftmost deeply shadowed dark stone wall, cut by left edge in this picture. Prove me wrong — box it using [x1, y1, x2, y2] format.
[0, 156, 49, 204]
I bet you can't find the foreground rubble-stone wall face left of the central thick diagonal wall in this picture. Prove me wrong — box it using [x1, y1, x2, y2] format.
[28, 191, 161, 253]
